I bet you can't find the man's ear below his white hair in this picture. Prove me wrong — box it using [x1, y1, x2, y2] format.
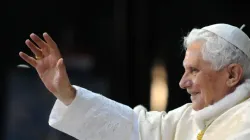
[227, 64, 243, 87]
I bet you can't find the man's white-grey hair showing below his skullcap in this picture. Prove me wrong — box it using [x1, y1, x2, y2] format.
[183, 28, 250, 79]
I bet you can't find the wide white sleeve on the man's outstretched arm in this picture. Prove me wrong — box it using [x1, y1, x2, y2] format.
[49, 86, 139, 140]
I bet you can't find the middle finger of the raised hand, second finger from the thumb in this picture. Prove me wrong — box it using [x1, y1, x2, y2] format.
[30, 33, 49, 56]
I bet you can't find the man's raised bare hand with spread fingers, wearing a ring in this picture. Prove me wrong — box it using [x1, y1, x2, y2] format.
[19, 33, 75, 105]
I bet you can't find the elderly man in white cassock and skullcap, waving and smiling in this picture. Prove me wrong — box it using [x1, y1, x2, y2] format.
[20, 24, 250, 140]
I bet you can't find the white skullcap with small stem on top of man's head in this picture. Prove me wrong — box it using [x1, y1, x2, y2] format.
[202, 23, 250, 58]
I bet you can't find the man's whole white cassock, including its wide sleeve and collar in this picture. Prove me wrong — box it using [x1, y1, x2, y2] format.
[49, 80, 250, 140]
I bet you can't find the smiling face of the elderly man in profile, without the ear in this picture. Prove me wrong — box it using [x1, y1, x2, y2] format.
[179, 42, 228, 111]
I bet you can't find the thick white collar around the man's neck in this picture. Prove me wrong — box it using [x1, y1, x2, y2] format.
[192, 79, 250, 129]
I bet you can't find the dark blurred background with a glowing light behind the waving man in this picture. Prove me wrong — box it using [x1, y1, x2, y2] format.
[0, 0, 250, 140]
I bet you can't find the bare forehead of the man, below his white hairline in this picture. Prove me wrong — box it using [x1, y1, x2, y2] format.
[183, 43, 203, 67]
